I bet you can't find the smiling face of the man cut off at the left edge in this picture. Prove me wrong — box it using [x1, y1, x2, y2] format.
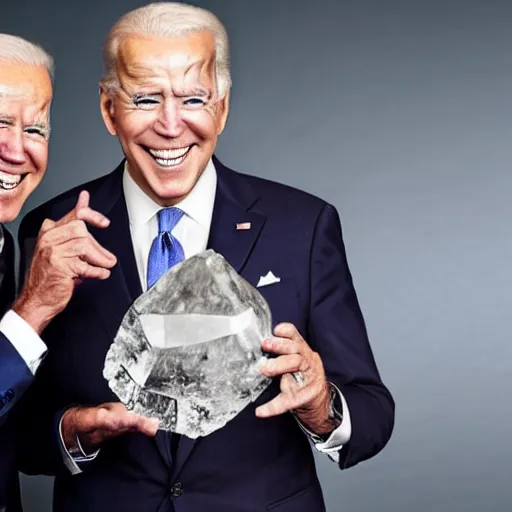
[0, 60, 52, 223]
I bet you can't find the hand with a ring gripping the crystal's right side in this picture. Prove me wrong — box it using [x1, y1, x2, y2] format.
[256, 323, 338, 435]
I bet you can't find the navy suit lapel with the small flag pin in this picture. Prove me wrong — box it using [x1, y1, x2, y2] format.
[174, 157, 265, 477]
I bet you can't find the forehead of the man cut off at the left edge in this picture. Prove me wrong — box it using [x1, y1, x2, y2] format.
[0, 60, 52, 109]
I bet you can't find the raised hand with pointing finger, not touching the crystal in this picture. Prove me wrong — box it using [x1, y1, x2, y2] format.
[13, 191, 117, 334]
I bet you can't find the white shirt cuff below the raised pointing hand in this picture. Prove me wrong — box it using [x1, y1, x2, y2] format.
[0, 310, 47, 374]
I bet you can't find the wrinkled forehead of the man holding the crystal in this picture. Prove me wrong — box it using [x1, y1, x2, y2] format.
[118, 30, 215, 79]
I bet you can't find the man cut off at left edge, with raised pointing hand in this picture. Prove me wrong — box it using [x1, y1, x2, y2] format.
[0, 34, 154, 512]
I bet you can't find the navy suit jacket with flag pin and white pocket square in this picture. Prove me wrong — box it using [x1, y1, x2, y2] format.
[15, 159, 394, 512]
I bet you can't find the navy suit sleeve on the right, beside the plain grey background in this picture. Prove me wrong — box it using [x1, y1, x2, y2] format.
[307, 205, 395, 469]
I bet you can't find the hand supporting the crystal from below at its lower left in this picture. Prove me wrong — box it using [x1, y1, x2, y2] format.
[61, 402, 159, 453]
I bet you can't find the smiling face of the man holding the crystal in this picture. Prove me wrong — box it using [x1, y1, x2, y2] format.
[101, 31, 229, 206]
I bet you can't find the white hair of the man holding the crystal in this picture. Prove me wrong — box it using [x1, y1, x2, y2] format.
[101, 2, 231, 97]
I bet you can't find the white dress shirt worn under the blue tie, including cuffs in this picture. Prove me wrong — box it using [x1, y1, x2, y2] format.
[61, 160, 351, 474]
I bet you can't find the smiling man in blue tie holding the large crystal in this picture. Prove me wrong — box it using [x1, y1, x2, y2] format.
[15, 3, 394, 512]
